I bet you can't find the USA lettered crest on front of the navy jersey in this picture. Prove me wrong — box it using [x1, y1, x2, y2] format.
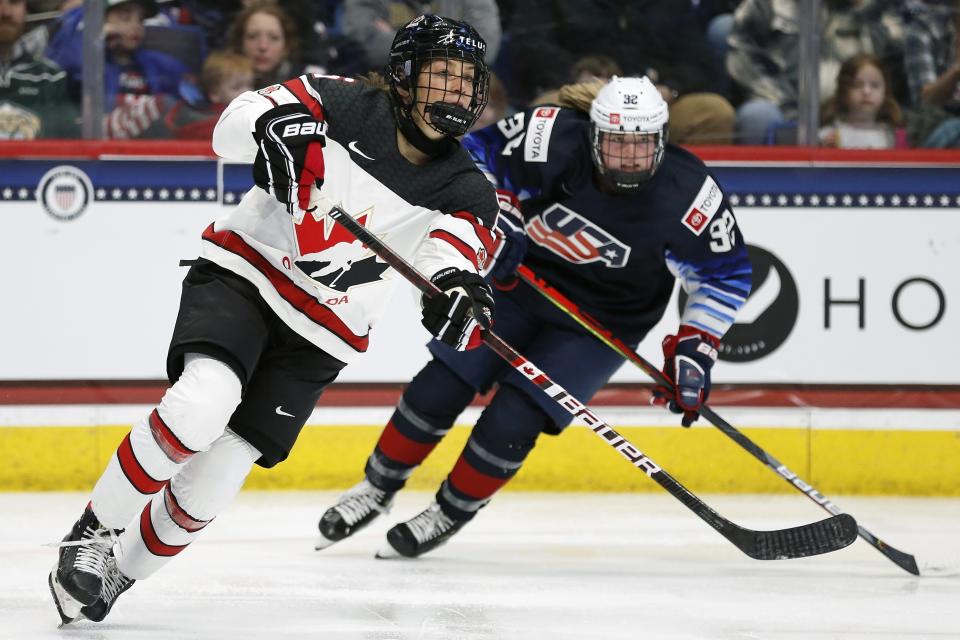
[526, 203, 630, 269]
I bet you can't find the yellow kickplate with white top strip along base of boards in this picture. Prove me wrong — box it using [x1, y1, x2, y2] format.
[0, 405, 960, 496]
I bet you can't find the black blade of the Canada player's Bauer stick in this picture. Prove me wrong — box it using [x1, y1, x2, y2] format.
[738, 513, 858, 560]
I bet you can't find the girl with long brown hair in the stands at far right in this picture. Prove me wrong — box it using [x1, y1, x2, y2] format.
[820, 53, 907, 149]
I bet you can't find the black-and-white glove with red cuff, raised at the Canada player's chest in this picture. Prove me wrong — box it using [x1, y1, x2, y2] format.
[253, 104, 326, 214]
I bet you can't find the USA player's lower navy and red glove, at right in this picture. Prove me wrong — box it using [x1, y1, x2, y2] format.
[651, 325, 720, 427]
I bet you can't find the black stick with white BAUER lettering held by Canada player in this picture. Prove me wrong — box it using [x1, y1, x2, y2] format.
[329, 207, 857, 560]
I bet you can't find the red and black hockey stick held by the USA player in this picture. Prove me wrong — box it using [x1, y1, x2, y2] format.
[518, 265, 920, 576]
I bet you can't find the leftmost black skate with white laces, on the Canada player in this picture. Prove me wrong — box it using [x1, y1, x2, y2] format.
[47, 505, 118, 624]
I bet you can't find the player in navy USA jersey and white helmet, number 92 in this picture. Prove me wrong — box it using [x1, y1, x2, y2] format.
[316, 78, 751, 557]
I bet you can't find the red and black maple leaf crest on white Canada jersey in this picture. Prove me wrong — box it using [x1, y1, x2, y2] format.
[293, 210, 389, 293]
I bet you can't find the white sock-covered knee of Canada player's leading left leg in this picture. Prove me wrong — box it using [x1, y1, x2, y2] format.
[157, 353, 242, 451]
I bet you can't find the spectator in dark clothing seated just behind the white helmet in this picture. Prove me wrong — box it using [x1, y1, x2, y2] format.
[508, 0, 735, 144]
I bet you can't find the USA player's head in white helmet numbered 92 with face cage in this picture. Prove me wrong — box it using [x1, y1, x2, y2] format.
[590, 76, 670, 192]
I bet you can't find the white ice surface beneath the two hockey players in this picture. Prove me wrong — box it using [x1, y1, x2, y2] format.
[0, 492, 960, 640]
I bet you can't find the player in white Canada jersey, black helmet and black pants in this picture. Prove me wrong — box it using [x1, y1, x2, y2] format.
[48, 15, 498, 624]
